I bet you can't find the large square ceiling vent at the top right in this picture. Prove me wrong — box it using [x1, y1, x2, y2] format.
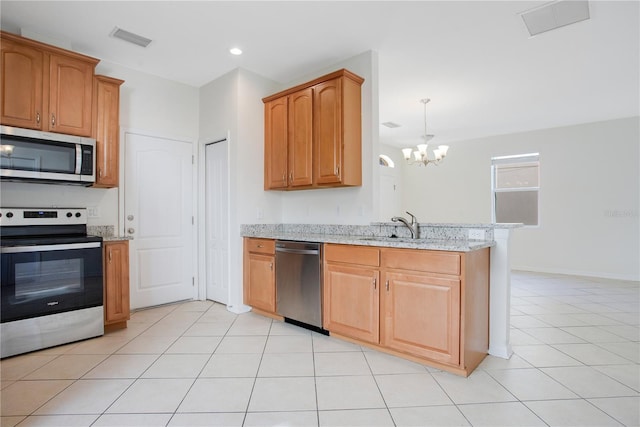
[520, 0, 589, 36]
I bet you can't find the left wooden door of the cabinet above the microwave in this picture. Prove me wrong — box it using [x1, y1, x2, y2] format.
[0, 39, 44, 129]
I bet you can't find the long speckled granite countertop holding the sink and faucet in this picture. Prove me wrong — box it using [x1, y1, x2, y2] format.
[241, 223, 495, 252]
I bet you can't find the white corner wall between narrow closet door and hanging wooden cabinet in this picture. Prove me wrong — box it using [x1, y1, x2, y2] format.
[199, 69, 281, 310]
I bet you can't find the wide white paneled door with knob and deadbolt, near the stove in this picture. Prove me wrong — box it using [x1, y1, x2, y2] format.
[124, 133, 195, 308]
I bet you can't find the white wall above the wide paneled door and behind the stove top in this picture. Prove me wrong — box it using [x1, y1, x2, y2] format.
[0, 61, 198, 229]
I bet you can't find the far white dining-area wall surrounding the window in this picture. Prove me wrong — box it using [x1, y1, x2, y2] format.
[403, 117, 640, 280]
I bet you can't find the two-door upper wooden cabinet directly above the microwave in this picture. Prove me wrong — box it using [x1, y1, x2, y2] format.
[0, 32, 99, 136]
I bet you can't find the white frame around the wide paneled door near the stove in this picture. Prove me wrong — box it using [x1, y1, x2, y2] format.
[115, 128, 202, 300]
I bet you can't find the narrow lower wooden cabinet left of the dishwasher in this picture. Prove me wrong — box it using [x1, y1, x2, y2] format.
[243, 238, 276, 313]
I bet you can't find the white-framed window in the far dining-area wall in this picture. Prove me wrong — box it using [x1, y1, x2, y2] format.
[491, 153, 540, 226]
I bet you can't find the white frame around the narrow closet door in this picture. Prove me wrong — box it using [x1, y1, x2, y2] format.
[199, 130, 231, 304]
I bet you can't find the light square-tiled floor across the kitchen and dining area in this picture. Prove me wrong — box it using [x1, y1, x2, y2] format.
[0, 272, 640, 427]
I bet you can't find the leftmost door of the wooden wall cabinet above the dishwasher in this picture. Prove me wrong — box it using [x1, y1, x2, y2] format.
[264, 96, 288, 190]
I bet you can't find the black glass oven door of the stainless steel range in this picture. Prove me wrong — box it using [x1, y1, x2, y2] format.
[0, 242, 103, 323]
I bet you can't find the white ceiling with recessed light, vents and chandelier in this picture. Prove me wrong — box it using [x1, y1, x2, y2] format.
[0, 0, 640, 146]
